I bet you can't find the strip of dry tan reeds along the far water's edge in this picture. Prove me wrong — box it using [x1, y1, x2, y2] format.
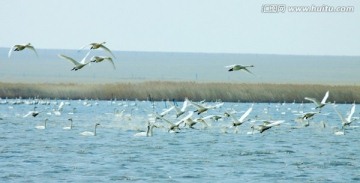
[0, 81, 360, 103]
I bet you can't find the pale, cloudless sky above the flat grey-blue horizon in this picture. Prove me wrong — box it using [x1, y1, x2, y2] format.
[0, 0, 360, 56]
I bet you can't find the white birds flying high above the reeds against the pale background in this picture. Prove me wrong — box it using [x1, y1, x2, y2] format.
[8, 42, 254, 74]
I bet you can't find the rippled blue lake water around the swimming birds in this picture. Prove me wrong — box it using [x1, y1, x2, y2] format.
[0, 99, 360, 182]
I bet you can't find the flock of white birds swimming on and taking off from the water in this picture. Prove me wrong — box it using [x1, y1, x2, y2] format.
[0, 91, 359, 137]
